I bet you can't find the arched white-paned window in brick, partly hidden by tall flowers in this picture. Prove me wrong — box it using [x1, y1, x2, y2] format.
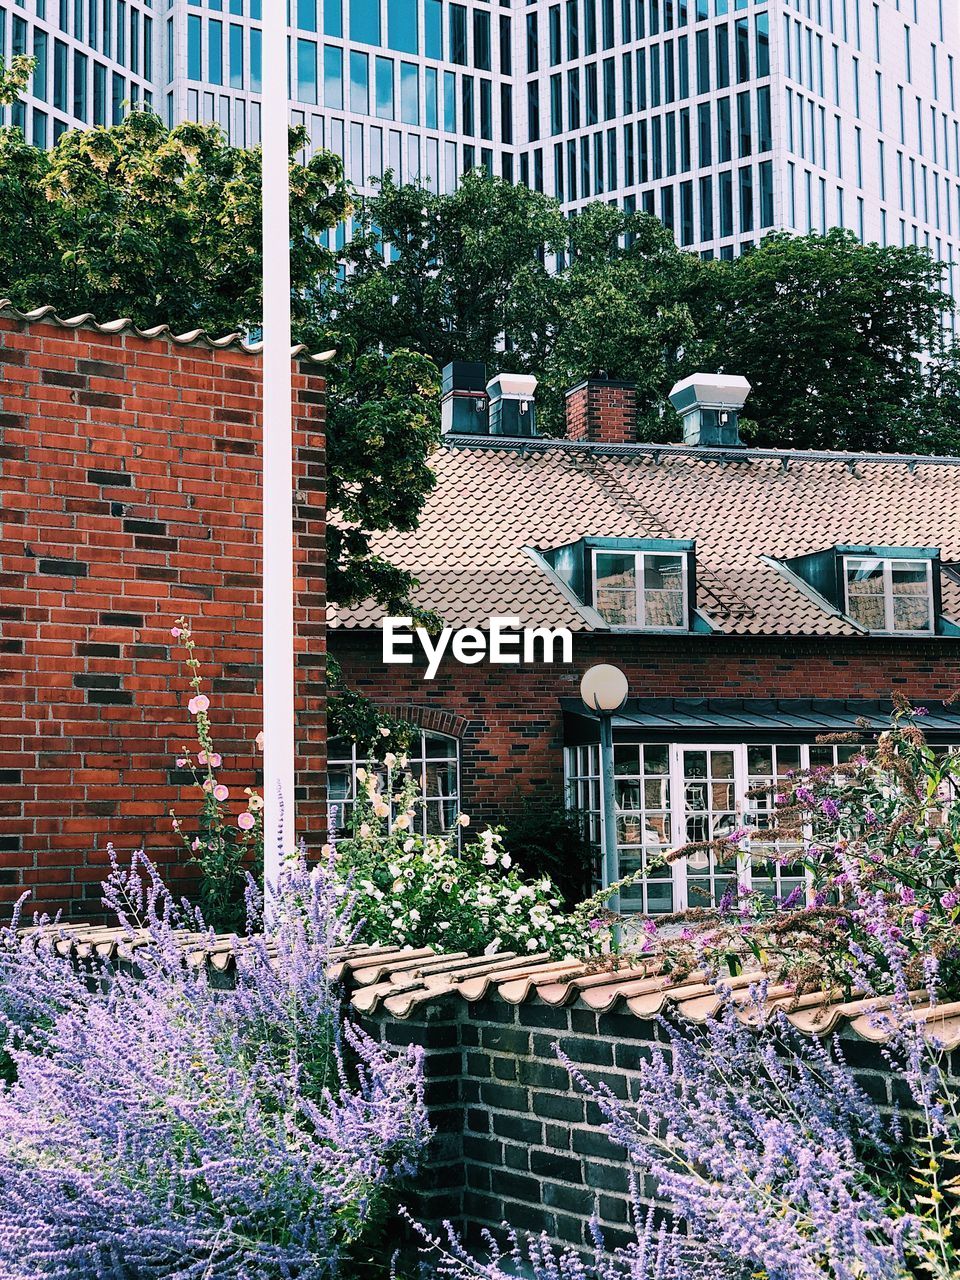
[326, 730, 460, 836]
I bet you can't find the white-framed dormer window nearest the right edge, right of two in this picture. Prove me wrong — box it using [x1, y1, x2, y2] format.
[844, 556, 934, 635]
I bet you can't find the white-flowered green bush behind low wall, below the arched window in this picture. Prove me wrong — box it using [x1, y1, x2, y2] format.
[334, 753, 599, 954]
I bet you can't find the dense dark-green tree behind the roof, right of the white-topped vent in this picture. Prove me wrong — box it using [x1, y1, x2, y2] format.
[696, 230, 955, 452]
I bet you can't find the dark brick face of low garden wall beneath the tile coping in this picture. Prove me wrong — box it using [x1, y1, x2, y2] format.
[366, 993, 960, 1247]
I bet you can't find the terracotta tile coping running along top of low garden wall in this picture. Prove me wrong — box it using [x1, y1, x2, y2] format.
[23, 924, 960, 1050]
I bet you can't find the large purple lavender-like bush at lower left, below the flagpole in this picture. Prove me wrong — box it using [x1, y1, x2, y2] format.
[0, 855, 428, 1280]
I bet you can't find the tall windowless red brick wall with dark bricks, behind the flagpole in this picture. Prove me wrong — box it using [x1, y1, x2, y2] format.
[0, 319, 325, 915]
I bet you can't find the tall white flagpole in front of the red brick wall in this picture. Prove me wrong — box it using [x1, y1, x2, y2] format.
[261, 0, 296, 910]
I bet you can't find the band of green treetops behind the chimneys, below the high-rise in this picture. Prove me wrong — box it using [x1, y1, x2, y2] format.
[337, 172, 960, 453]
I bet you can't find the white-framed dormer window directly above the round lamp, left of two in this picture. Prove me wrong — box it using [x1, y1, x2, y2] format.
[593, 549, 690, 631]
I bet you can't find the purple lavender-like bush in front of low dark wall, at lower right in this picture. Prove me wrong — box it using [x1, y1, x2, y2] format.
[417, 989, 913, 1280]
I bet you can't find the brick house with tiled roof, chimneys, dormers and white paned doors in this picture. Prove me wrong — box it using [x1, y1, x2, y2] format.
[329, 366, 960, 911]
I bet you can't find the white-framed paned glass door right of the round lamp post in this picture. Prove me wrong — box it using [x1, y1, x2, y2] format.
[673, 745, 749, 906]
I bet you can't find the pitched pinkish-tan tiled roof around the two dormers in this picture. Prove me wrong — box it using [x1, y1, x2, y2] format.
[330, 438, 960, 636]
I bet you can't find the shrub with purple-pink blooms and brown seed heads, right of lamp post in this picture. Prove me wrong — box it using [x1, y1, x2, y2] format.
[591, 699, 960, 996]
